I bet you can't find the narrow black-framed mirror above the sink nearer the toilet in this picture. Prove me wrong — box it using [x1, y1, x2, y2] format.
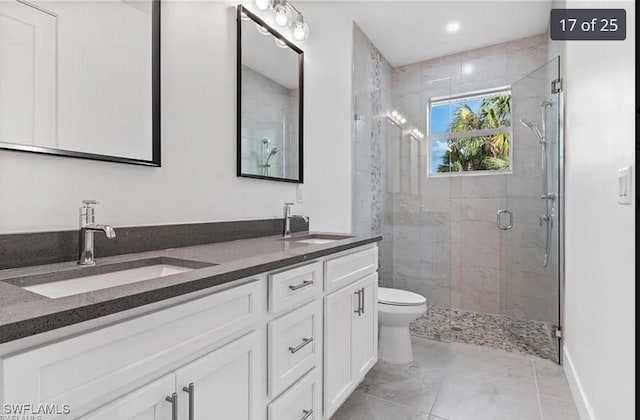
[237, 5, 304, 183]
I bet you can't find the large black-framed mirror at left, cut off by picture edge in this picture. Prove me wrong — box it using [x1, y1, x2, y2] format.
[0, 0, 161, 166]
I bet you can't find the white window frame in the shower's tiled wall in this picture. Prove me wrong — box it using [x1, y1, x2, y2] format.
[425, 85, 514, 178]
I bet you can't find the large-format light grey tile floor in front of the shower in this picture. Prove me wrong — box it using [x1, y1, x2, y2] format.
[331, 337, 579, 420]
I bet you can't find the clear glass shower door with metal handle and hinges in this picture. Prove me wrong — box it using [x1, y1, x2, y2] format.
[496, 57, 562, 362]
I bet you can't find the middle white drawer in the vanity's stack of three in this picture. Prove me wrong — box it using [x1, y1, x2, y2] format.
[267, 300, 322, 397]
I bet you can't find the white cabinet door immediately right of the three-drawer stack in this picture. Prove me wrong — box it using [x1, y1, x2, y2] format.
[324, 284, 358, 418]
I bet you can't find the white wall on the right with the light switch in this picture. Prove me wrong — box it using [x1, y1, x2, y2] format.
[564, 1, 637, 420]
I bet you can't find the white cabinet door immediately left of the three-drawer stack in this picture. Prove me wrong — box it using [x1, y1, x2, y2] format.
[176, 331, 266, 420]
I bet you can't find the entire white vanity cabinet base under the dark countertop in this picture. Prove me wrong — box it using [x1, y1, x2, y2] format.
[0, 244, 378, 420]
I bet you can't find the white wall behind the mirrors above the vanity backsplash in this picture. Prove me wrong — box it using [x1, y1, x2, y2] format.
[0, 0, 352, 233]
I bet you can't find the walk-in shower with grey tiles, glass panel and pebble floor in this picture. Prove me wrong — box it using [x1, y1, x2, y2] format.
[381, 51, 562, 361]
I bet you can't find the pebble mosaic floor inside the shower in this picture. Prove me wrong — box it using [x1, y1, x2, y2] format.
[410, 307, 557, 360]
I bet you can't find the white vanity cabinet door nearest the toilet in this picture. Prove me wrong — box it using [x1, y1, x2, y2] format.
[352, 273, 378, 381]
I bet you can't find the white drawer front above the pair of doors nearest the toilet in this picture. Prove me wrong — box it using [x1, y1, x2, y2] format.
[324, 247, 378, 292]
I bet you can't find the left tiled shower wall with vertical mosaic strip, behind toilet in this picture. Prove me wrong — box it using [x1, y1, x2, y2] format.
[352, 25, 393, 285]
